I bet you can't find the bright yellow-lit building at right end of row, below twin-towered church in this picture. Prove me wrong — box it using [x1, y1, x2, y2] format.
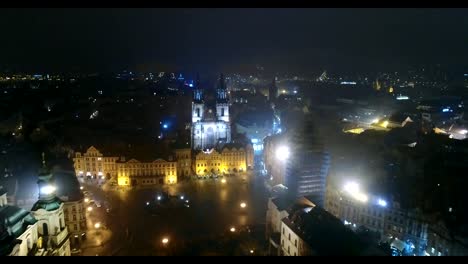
[194, 144, 249, 176]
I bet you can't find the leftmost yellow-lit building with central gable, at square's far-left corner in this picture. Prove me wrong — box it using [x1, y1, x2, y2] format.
[73, 146, 118, 179]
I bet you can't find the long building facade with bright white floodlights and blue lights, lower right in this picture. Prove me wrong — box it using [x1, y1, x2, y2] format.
[325, 186, 438, 256]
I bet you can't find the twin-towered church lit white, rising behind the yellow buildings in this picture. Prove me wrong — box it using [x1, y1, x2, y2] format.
[192, 74, 231, 150]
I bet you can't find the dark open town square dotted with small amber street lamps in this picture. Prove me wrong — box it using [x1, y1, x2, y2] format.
[79, 171, 267, 255]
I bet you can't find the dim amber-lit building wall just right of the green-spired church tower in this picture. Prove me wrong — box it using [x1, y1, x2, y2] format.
[63, 199, 87, 248]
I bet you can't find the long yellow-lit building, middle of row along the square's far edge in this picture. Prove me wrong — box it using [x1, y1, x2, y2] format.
[117, 159, 177, 186]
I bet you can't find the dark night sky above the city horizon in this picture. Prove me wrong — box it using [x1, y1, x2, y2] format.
[0, 9, 468, 72]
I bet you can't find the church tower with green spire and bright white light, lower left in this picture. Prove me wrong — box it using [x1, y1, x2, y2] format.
[31, 153, 70, 256]
